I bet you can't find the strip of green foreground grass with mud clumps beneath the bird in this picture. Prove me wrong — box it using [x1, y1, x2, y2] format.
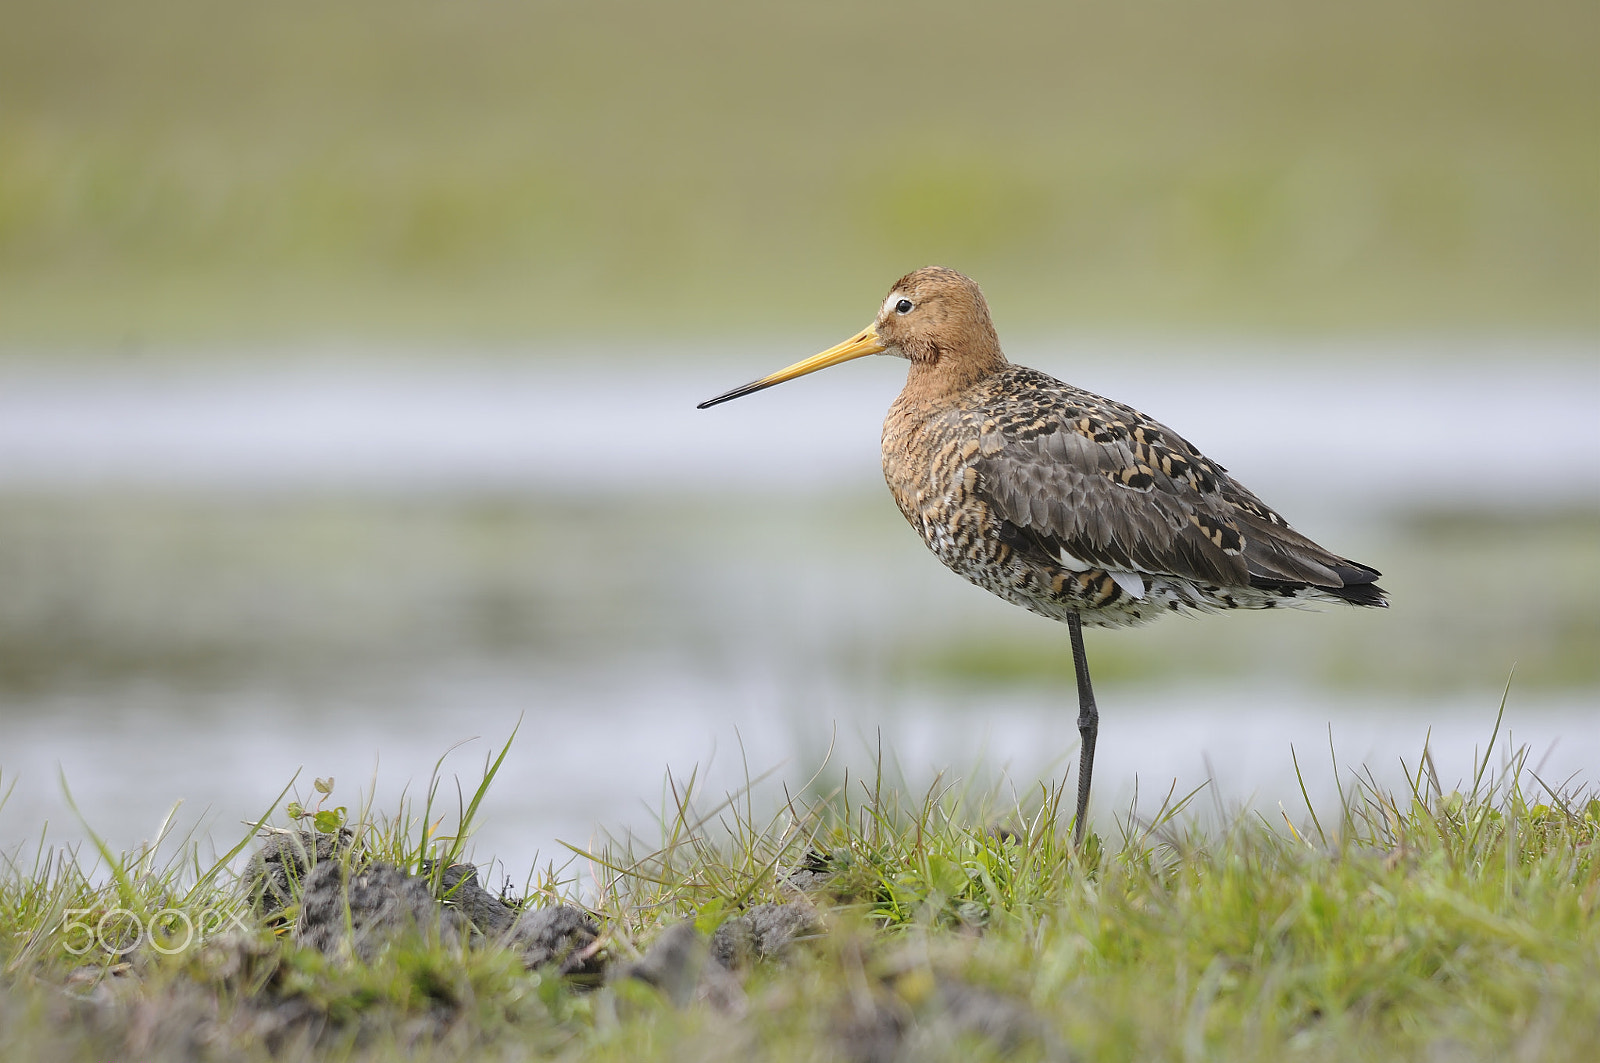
[0, 714, 1600, 1061]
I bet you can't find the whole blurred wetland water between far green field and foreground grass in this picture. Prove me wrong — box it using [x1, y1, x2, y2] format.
[0, 341, 1600, 877]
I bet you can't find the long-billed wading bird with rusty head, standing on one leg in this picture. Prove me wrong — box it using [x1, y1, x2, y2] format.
[701, 266, 1384, 836]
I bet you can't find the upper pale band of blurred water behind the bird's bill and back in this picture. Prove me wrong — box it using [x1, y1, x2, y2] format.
[0, 341, 1600, 506]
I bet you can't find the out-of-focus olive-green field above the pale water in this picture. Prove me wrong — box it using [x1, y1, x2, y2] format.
[0, 0, 1600, 344]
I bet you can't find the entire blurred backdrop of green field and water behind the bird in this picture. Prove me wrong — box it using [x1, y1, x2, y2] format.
[0, 0, 1600, 876]
